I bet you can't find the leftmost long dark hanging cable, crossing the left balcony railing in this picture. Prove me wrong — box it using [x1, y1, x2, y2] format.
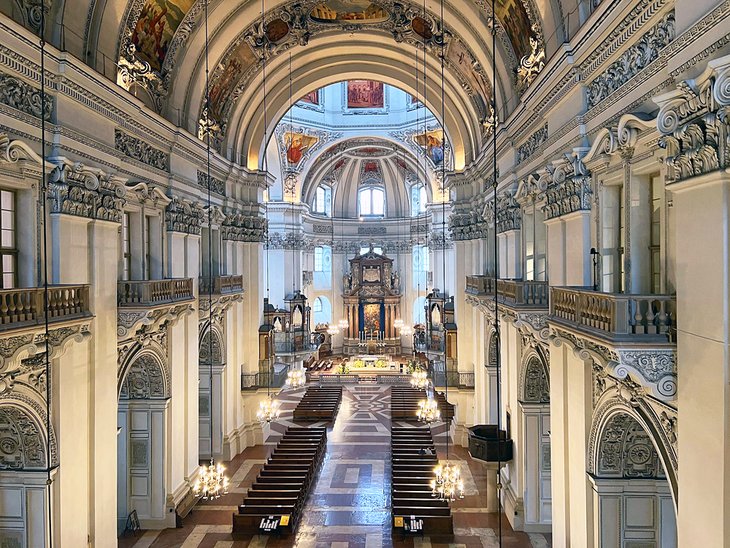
[39, 5, 53, 548]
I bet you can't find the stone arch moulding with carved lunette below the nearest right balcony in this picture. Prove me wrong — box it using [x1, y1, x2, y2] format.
[587, 396, 677, 510]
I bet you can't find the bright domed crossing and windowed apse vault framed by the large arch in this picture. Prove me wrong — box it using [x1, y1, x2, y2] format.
[266, 80, 444, 219]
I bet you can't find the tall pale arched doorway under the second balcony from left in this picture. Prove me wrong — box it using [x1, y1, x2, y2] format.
[117, 349, 175, 533]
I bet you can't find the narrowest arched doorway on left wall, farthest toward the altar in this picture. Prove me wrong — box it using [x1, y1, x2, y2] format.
[198, 325, 226, 459]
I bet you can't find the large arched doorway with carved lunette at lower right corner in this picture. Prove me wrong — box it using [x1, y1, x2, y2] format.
[589, 409, 677, 548]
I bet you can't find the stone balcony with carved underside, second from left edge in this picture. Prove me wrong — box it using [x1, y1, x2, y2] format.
[117, 278, 195, 341]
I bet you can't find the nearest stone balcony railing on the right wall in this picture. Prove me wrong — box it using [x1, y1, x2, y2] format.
[550, 287, 677, 340]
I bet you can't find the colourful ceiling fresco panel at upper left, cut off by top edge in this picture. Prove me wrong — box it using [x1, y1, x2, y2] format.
[132, 0, 194, 72]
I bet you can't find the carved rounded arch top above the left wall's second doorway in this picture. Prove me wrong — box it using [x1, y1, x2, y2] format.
[118, 347, 171, 400]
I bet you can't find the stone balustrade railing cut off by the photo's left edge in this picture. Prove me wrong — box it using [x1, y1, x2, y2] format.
[0, 285, 91, 331]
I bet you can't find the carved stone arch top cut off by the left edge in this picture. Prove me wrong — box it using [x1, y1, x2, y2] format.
[0, 398, 53, 470]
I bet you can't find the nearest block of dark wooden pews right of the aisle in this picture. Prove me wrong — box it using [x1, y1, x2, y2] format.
[390, 426, 454, 535]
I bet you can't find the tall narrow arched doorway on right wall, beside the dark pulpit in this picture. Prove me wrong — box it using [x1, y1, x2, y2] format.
[519, 350, 552, 531]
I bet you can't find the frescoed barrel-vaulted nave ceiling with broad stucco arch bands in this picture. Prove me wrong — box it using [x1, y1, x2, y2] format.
[0, 0, 564, 170]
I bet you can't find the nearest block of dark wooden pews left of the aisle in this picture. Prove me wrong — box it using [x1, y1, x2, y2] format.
[233, 426, 327, 540]
